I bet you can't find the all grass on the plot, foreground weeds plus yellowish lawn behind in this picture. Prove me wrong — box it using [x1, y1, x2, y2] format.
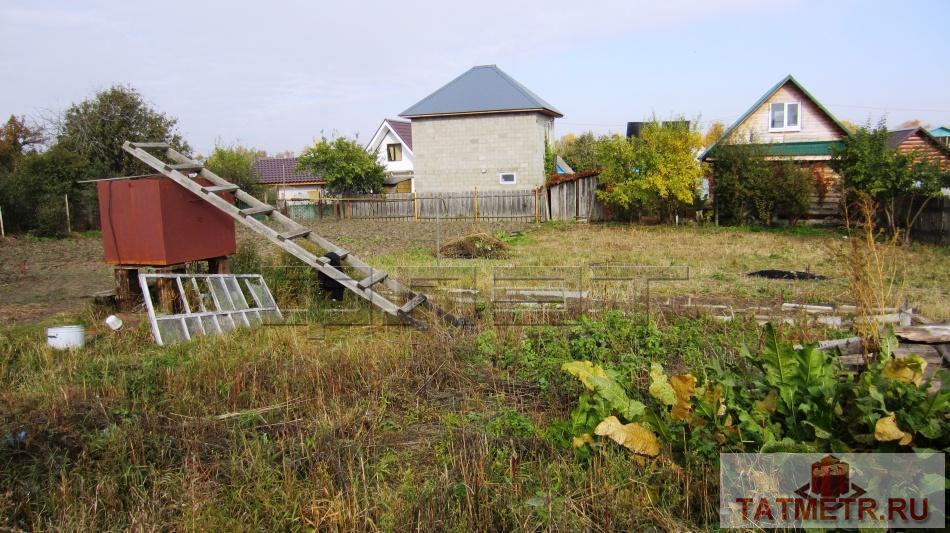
[0, 222, 950, 531]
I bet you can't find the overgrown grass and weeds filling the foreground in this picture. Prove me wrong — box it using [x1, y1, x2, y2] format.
[0, 302, 772, 531]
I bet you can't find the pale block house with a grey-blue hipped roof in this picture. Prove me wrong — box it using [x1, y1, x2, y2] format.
[400, 65, 563, 192]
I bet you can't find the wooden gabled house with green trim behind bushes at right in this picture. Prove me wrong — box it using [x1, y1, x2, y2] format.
[700, 75, 849, 222]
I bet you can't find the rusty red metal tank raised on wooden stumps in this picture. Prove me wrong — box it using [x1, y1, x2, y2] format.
[96, 175, 236, 266]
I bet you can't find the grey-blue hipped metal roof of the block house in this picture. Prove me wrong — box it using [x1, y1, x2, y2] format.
[399, 65, 563, 117]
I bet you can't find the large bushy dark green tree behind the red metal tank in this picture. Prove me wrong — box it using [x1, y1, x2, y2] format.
[56, 85, 191, 176]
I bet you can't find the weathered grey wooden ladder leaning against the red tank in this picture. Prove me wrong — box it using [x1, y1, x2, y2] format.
[122, 141, 465, 329]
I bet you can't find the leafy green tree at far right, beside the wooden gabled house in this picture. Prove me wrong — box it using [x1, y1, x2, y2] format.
[831, 121, 950, 239]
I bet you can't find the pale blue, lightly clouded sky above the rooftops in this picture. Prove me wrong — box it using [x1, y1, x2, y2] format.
[0, 0, 950, 154]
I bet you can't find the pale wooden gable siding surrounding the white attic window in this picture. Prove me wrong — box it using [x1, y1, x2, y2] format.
[736, 82, 844, 143]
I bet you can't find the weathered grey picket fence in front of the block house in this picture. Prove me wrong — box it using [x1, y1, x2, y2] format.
[280, 189, 547, 222]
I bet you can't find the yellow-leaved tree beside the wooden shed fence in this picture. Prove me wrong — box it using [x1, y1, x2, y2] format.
[597, 120, 702, 221]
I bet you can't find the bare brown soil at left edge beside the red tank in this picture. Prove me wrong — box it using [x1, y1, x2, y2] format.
[0, 237, 112, 324]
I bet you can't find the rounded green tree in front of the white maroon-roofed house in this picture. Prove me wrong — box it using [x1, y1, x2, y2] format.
[297, 137, 386, 195]
